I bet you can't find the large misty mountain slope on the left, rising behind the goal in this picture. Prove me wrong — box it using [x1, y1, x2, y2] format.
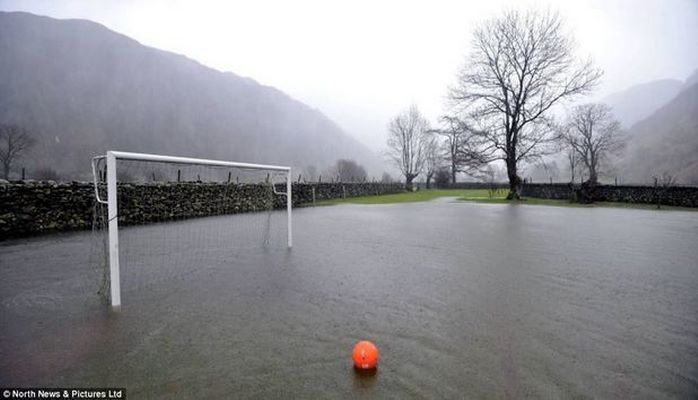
[0, 12, 383, 178]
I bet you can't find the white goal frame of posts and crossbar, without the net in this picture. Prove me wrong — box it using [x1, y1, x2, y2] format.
[92, 151, 293, 310]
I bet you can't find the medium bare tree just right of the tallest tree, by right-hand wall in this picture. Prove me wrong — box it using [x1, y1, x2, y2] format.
[563, 104, 624, 184]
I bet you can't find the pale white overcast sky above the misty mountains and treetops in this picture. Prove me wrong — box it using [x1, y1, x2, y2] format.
[0, 0, 698, 151]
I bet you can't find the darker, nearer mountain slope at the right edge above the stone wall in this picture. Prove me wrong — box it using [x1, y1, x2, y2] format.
[620, 84, 698, 184]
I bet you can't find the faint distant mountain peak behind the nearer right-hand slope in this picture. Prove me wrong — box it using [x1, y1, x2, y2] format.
[603, 79, 683, 128]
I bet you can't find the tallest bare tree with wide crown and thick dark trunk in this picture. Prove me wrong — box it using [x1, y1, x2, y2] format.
[450, 11, 601, 199]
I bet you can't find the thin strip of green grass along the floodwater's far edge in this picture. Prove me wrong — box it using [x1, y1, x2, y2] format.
[316, 189, 698, 211]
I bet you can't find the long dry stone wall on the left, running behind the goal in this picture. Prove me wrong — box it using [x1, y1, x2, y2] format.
[0, 181, 403, 240]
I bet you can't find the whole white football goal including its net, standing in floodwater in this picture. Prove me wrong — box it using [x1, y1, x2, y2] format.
[92, 151, 292, 308]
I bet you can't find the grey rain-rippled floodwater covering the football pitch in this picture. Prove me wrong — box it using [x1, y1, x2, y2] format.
[0, 199, 698, 399]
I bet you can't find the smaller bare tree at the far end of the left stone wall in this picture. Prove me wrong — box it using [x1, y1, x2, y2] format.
[387, 105, 429, 190]
